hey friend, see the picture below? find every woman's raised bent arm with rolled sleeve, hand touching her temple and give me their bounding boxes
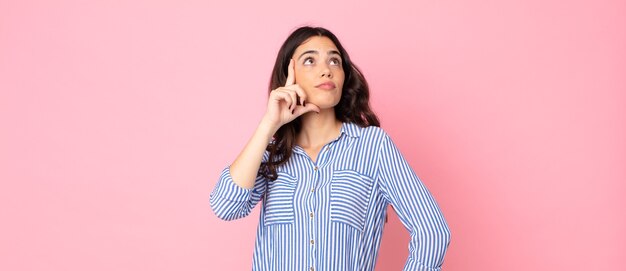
[210,60,319,220]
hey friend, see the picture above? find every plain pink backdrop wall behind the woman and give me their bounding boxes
[0,0,626,271]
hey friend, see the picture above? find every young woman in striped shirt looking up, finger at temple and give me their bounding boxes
[210,27,450,271]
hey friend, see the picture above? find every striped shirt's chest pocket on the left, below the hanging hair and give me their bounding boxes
[263,172,297,226]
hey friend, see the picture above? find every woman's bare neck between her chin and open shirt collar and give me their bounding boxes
[296,108,342,148]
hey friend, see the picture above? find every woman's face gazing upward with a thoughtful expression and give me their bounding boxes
[292,36,345,109]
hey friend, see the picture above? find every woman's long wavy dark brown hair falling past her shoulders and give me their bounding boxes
[259,26,380,180]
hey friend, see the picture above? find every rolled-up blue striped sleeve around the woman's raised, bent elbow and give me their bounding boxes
[209,166,266,220]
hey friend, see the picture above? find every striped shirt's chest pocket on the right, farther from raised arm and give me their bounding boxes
[330,170,373,231]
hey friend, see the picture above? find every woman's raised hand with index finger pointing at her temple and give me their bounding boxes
[263,59,320,131]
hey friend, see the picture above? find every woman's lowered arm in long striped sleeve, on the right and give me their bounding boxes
[378,134,450,271]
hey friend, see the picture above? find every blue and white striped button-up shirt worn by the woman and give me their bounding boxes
[210,123,450,271]
